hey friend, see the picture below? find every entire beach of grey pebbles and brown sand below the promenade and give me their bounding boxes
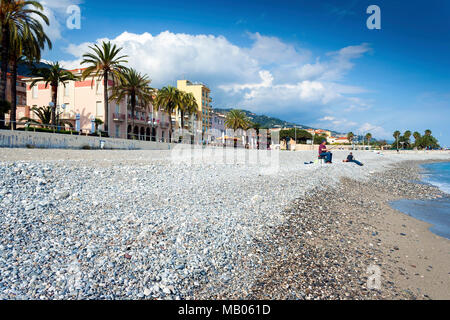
[0,149,450,299]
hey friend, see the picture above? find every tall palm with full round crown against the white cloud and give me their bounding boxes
[81,41,128,132]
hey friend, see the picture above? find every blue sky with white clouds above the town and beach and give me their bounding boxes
[42,0,450,146]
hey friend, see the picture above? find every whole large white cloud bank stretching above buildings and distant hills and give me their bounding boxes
[62,31,371,134]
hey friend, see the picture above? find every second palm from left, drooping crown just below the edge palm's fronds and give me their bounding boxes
[9,22,52,129]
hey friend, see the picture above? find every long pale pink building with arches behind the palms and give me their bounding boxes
[26,69,175,141]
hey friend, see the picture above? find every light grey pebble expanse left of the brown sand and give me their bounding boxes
[0,150,448,299]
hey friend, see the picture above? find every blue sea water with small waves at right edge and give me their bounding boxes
[391,162,450,239]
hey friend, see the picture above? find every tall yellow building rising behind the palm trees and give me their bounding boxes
[177,80,212,133]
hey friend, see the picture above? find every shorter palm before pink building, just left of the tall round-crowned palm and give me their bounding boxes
[30,62,78,125]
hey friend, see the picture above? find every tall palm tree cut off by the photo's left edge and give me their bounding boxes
[0,0,49,127]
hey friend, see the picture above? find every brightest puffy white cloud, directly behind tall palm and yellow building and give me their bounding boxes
[64,31,260,86]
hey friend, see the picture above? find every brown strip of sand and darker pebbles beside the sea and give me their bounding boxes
[243,161,450,299]
